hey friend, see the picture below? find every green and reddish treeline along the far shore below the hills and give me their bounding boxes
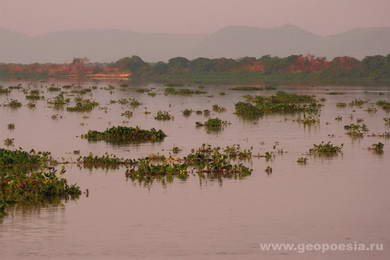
[0,54,390,85]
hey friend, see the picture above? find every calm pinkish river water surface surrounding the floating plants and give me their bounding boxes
[0,82,390,259]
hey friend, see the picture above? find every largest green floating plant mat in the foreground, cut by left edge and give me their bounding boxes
[0,148,81,217]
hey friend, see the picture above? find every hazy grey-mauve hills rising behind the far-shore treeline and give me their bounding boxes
[0,25,390,63]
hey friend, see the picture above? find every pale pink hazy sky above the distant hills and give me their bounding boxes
[0,0,390,35]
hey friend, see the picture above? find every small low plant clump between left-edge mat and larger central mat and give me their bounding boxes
[77,153,134,169]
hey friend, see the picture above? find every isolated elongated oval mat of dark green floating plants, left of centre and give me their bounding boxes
[81,126,166,144]
